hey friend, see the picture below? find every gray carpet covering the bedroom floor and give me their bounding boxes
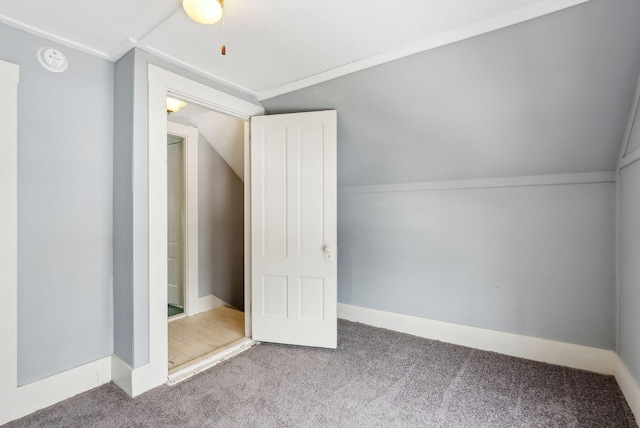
[3,321,637,428]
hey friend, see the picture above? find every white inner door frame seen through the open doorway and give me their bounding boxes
[167,121,199,319]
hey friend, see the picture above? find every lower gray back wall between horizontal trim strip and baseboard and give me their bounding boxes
[338,184,615,349]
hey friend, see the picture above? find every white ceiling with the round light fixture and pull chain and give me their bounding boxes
[0,0,588,99]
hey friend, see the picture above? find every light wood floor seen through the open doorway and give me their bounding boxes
[169,307,244,374]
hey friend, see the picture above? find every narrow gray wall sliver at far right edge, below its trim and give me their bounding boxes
[618,157,640,382]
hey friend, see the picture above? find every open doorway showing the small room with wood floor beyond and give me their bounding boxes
[166,102,245,380]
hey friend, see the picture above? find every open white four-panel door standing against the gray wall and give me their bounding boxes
[251,110,337,348]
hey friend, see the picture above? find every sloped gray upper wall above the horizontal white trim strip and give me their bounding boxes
[263,0,640,186]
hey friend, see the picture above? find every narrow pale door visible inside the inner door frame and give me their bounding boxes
[167,135,184,307]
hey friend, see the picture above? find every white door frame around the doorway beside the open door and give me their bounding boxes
[146,64,264,395]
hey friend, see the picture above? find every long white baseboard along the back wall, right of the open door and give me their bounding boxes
[338,303,616,375]
